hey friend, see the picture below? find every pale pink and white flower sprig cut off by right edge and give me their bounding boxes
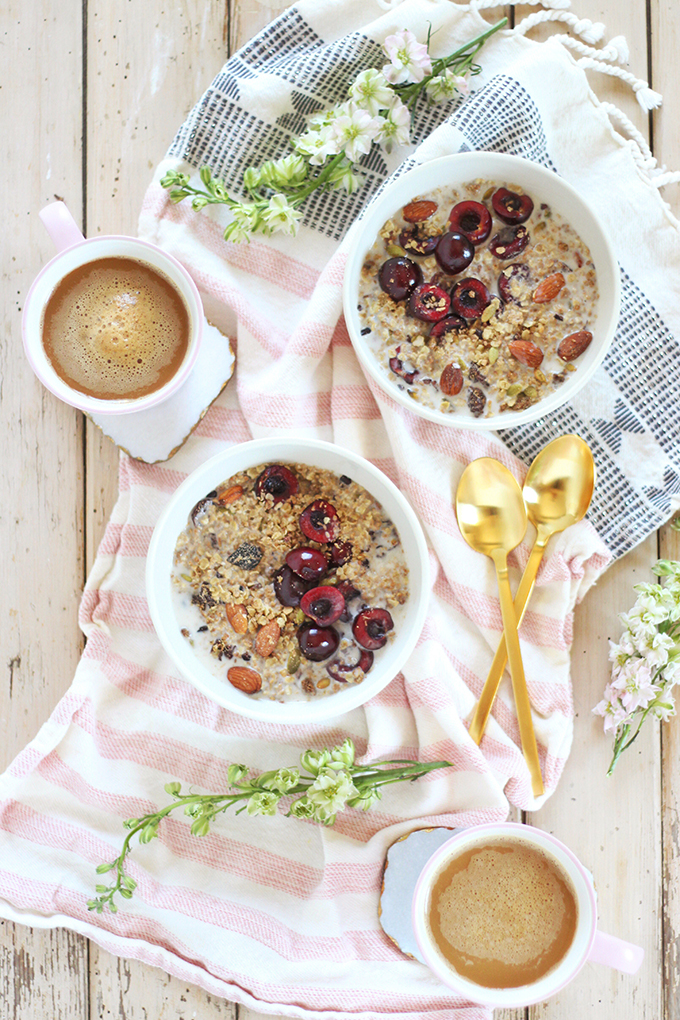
[592,560,680,775]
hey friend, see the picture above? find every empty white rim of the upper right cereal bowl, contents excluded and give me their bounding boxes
[343,149,621,431]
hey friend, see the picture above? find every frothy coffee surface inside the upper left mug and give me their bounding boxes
[43,258,190,400]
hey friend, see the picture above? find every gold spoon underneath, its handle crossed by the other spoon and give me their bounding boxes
[470,436,595,744]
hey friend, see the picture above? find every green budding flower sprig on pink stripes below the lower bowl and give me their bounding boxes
[88,738,451,914]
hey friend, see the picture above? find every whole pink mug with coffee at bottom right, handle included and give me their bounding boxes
[411,822,643,1009]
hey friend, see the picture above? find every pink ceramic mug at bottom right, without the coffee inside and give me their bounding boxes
[412,822,644,1009]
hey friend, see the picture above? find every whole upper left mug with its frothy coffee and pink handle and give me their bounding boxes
[21,202,204,415]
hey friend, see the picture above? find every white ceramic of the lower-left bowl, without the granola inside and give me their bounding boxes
[146,439,429,723]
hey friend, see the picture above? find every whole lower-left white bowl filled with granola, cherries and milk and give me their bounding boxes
[146,439,429,723]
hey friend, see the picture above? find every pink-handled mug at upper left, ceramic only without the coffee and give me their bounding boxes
[21,202,203,414]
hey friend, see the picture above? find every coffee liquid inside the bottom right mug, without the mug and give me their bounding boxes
[427,839,578,988]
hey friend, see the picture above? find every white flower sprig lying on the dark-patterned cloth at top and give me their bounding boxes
[160,17,508,242]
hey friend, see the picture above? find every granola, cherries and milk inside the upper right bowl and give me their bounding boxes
[358,180,598,417]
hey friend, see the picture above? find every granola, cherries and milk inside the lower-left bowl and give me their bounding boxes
[172,464,409,701]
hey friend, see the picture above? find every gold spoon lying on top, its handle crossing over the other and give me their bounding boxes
[456,457,543,797]
